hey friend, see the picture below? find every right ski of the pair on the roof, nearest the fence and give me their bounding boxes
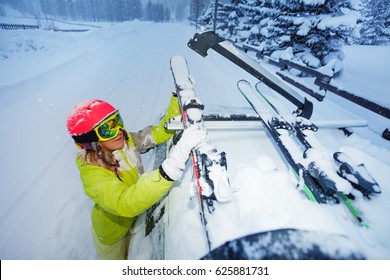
[255,82,381,197]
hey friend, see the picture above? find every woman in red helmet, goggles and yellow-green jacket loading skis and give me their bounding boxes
[67,96,206,259]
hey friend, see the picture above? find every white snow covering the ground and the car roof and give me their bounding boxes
[0,9,390,260]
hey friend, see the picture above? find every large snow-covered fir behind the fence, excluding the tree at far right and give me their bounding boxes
[202,0,359,72]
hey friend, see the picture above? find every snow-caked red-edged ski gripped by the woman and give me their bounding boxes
[170,55,232,251]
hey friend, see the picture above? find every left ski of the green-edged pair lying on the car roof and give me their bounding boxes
[237,80,368,227]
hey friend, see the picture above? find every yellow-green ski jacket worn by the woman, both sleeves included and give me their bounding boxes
[76,97,180,244]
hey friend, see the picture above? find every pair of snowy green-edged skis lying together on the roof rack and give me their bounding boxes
[237,80,381,227]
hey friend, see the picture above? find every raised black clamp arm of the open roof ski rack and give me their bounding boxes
[188,31,313,119]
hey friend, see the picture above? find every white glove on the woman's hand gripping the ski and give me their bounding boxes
[161,127,206,181]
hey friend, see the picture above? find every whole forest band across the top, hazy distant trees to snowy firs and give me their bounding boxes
[0,0,390,74]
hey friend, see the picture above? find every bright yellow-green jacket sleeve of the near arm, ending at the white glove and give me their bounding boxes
[77,159,173,217]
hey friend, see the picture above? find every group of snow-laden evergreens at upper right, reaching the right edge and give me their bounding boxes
[198,0,390,75]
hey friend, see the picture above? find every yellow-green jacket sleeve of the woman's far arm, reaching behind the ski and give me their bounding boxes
[130,96,180,152]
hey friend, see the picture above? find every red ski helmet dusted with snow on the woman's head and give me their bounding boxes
[66,99,118,144]
